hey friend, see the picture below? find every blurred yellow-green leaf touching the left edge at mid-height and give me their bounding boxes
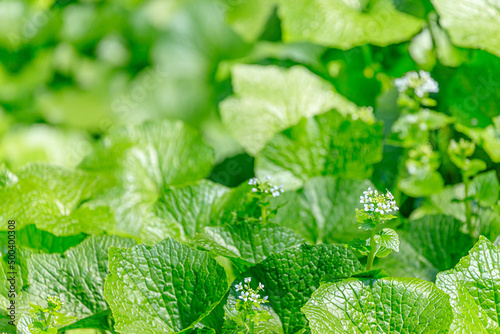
[0,164,114,236]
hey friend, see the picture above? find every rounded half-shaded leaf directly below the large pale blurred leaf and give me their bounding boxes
[255,111,382,188]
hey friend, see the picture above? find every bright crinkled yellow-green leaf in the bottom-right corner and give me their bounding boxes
[436,237,500,333]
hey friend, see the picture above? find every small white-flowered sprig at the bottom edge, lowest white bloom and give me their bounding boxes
[232,277,273,334]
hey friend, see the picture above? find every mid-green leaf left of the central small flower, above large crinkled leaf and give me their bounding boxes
[153,180,229,237]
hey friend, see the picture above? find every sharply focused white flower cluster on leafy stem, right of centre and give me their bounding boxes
[349,187,399,270]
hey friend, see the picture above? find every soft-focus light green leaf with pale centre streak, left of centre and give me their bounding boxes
[82,121,214,243]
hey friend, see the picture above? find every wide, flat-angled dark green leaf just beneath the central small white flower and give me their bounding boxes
[193,222,304,269]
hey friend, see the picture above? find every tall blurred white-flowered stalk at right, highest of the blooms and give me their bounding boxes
[389,71,452,197]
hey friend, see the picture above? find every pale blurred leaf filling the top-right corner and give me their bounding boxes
[432,0,500,56]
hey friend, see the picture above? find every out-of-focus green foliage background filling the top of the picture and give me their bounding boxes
[0,0,500,177]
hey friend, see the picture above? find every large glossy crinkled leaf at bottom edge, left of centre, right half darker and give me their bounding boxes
[104,238,228,334]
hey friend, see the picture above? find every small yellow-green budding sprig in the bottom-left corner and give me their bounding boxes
[29,296,77,334]
